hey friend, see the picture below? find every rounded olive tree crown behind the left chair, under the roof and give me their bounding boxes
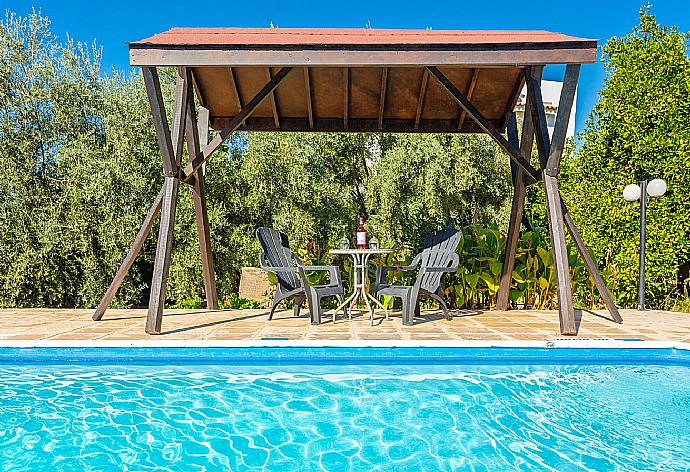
[236,133,371,258]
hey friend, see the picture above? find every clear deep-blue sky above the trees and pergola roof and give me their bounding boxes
[4,0,690,131]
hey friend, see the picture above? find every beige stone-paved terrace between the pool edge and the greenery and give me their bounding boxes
[0,308,690,343]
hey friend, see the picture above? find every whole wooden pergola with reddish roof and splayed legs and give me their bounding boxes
[88,28,622,334]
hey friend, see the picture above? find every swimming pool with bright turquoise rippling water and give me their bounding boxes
[0,346,690,471]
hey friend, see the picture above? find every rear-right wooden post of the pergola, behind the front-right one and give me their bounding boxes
[496,66,543,310]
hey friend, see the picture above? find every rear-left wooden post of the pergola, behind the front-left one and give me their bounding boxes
[186,97,218,310]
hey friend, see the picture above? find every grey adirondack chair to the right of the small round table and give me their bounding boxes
[374,229,462,326]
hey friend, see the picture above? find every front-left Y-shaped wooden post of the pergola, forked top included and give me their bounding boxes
[142,67,181,334]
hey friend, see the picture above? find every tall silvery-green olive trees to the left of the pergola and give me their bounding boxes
[0,13,160,306]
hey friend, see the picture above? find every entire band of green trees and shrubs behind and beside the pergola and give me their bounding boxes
[5,10,690,308]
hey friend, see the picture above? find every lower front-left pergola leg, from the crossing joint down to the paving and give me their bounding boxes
[146,177,180,334]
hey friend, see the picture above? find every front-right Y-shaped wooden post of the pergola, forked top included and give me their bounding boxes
[527,64,580,334]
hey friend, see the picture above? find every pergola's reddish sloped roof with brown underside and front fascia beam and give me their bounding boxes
[129,28,597,132]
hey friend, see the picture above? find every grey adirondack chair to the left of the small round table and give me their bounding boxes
[256,227,345,324]
